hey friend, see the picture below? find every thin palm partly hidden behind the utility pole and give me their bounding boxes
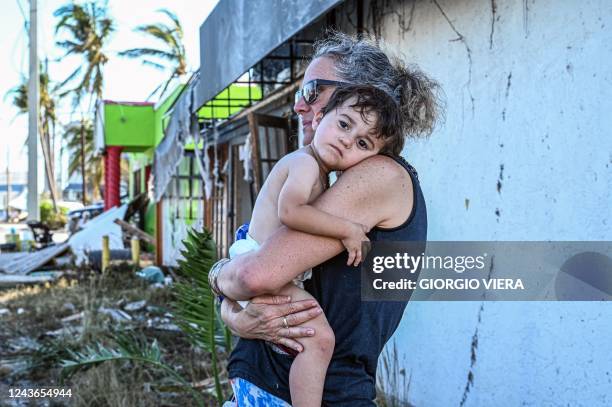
[9,64,58,212]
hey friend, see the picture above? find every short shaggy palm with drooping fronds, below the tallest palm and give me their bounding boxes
[64,119,103,204]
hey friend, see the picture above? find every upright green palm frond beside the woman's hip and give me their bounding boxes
[173,229,231,404]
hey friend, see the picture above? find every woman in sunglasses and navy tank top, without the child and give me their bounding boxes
[213,34,438,406]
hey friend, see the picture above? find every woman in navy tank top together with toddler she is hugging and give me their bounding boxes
[211,34,438,407]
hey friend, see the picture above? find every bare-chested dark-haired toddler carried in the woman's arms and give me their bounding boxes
[230,85,403,407]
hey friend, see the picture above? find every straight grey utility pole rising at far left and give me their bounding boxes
[28,0,40,220]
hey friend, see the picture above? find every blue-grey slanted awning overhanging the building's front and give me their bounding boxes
[196,0,342,108]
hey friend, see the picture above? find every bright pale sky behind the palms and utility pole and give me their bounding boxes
[0,0,218,185]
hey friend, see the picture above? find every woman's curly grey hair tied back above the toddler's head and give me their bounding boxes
[313,31,442,137]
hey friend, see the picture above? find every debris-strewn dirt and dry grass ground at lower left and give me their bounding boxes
[0,265,227,406]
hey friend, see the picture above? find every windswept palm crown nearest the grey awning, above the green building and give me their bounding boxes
[119,9,187,99]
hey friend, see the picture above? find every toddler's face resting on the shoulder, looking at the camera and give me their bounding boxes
[312,98,384,171]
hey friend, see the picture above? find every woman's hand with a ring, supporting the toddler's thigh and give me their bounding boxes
[221,295,323,352]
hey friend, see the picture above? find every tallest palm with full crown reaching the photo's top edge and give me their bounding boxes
[53,1,114,203]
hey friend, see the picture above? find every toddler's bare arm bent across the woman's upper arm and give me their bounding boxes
[278,154,369,265]
